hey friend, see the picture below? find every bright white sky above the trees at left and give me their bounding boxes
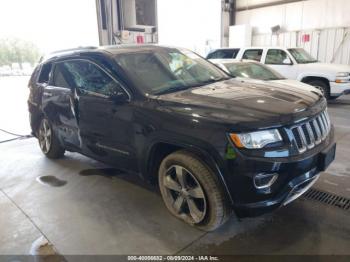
[0,0,98,53]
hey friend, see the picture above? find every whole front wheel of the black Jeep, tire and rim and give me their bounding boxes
[158,150,231,231]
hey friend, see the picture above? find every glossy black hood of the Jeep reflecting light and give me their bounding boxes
[157,79,326,129]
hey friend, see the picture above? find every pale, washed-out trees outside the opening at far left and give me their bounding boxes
[0,38,40,66]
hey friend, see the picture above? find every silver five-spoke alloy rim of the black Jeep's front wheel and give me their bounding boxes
[163,165,207,224]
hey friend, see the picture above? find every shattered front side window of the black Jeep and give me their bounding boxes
[63,60,123,96]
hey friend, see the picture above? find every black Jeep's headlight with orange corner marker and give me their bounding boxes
[230,129,282,149]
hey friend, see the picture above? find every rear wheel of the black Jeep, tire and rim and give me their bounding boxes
[38,117,65,159]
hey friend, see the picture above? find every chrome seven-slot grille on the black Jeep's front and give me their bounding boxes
[291,110,331,153]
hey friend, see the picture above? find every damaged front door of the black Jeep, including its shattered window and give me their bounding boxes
[59,59,137,171]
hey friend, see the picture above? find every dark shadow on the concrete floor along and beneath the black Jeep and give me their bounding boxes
[41,153,334,255]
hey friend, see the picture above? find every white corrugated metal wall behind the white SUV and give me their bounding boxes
[252,28,350,65]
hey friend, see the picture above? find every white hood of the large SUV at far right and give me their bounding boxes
[298,62,350,77]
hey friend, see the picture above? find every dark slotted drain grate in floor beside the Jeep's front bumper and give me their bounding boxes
[304,188,350,210]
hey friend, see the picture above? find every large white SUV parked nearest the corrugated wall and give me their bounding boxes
[207,47,350,99]
